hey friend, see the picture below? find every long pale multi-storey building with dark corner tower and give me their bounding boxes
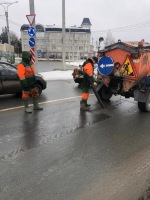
[21,18,93,60]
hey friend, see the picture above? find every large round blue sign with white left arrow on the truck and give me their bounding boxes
[98,56,114,75]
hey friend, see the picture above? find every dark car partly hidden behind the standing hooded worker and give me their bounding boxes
[0,61,47,95]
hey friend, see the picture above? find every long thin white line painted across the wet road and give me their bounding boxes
[0,94,94,112]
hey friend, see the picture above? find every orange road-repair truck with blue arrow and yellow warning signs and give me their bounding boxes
[97,42,150,112]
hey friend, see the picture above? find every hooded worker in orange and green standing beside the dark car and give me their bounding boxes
[17,51,43,113]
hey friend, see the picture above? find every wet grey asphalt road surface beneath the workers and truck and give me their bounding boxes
[0,61,150,200]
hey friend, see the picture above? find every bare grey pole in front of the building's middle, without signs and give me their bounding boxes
[62,0,66,70]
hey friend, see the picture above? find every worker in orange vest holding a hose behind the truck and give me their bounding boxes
[80,57,98,111]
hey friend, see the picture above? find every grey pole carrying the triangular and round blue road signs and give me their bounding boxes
[29,0,38,73]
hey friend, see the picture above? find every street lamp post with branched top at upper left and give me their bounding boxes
[0,1,18,45]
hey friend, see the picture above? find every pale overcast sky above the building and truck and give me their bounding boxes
[0,0,150,42]
